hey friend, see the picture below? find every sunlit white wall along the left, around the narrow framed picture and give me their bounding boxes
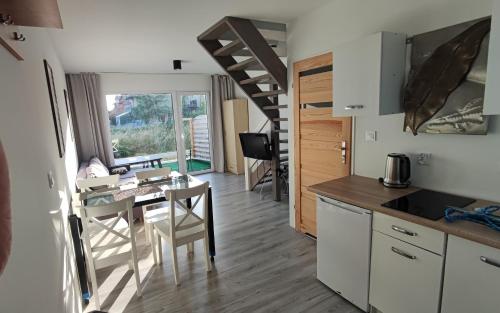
[0,29,81,313]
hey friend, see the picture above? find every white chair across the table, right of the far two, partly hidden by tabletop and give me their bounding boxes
[135,167,172,251]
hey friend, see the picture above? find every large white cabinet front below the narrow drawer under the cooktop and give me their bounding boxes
[370,231,443,313]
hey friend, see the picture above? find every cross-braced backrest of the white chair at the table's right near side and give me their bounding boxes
[165,182,208,238]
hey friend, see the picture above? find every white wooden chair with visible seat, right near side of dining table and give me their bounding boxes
[153,182,212,285]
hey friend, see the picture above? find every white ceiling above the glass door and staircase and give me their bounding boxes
[50,0,331,73]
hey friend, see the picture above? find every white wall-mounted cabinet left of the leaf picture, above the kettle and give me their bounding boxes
[333,32,406,116]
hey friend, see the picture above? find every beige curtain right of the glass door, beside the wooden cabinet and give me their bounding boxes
[210,75,234,172]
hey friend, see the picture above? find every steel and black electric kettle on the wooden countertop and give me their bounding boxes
[383,153,410,188]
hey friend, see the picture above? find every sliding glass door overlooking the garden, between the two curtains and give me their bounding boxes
[106,92,212,174]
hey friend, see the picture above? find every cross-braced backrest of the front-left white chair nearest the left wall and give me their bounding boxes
[80,197,135,264]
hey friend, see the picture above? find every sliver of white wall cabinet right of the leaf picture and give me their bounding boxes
[483,0,500,115]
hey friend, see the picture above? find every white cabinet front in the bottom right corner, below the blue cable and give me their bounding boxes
[441,235,500,313]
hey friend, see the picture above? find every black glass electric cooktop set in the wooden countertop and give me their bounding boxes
[382,189,476,221]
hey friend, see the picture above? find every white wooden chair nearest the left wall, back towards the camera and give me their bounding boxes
[80,197,142,310]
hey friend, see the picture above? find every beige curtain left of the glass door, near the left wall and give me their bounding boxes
[66,73,114,166]
